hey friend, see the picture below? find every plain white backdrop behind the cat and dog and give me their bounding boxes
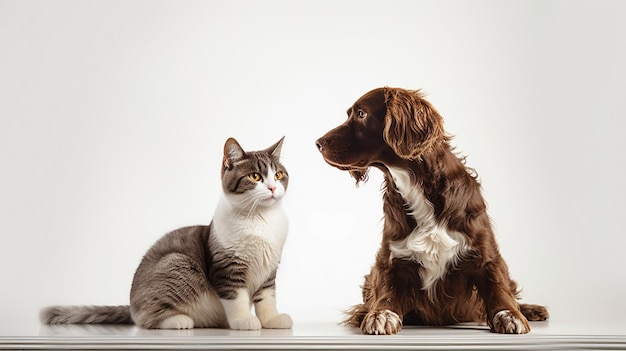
[0,0,626,334]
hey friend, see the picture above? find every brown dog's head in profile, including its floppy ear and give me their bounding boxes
[316,88,445,183]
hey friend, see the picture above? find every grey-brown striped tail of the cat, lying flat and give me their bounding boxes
[40,305,133,324]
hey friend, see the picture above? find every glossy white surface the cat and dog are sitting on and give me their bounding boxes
[0,321,626,350]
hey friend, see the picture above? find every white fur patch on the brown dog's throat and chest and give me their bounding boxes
[389,167,467,292]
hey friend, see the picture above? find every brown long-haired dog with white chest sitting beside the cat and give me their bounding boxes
[316,87,549,335]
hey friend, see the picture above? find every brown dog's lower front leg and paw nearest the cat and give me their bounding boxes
[360,267,404,335]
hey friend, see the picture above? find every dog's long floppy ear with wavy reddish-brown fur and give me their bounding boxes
[383,88,445,160]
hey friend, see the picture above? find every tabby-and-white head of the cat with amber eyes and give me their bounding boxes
[222,137,289,210]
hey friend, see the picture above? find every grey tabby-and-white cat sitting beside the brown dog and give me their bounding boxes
[41,137,293,330]
